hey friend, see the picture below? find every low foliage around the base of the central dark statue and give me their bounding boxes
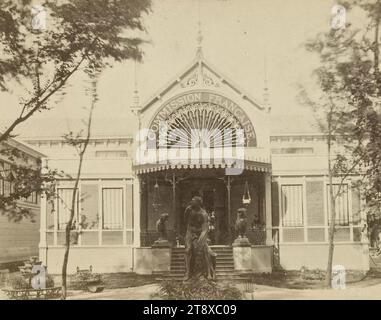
[151,279,242,300]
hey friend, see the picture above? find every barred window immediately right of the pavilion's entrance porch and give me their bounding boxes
[281,185,303,227]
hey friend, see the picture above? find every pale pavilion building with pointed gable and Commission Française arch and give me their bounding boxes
[27,50,369,274]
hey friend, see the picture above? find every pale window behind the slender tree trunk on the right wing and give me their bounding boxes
[327,184,349,226]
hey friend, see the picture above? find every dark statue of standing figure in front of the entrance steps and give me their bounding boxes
[185,196,216,280]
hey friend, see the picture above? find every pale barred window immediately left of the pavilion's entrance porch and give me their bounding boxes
[102,188,123,230]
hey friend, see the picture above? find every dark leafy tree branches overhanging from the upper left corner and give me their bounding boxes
[0,0,151,219]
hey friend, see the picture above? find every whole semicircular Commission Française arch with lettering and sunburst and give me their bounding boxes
[149,91,256,148]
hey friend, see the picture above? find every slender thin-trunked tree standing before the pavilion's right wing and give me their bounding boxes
[301,58,359,287]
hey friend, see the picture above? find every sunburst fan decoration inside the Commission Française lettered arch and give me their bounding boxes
[159,102,246,148]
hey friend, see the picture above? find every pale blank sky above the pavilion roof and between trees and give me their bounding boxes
[0,0,335,137]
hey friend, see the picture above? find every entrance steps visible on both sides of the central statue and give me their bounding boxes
[160,246,250,281]
